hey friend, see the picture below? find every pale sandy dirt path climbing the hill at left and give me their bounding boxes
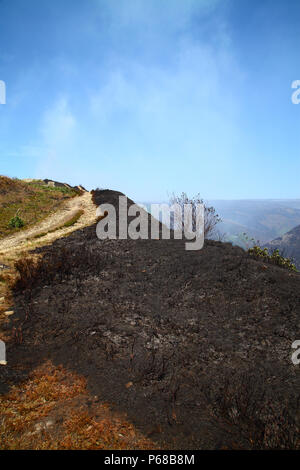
[0,192,96,263]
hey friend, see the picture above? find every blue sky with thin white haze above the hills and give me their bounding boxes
[0,0,300,201]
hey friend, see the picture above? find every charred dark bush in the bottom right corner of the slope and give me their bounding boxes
[207,372,300,450]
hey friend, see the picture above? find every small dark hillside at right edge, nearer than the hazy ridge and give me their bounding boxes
[265,225,300,270]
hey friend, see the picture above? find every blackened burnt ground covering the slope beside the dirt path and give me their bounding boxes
[0,191,300,449]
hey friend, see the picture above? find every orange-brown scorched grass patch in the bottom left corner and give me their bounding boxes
[0,362,155,450]
